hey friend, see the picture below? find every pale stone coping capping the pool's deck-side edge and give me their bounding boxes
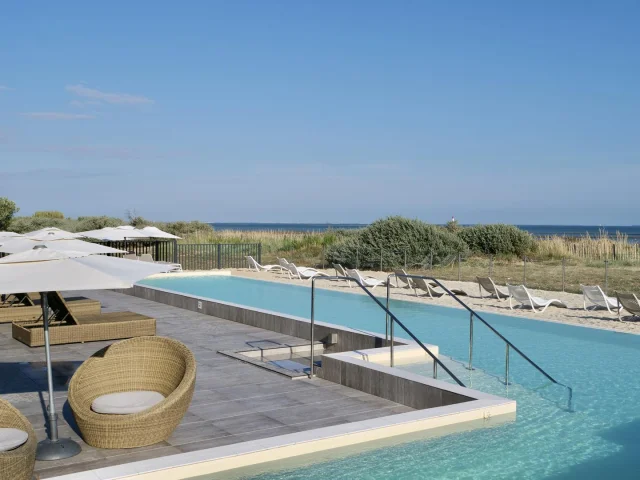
[52,285,516,480]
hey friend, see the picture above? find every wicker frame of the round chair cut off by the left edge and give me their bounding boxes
[0,399,38,480]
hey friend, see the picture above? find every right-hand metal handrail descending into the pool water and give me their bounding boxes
[390,273,573,410]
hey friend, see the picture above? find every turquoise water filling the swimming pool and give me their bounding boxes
[143,277,640,480]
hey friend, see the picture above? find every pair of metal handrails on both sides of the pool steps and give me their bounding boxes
[309,273,573,411]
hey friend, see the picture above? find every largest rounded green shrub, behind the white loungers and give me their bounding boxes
[326,217,467,270]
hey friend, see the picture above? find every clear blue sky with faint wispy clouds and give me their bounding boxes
[0,0,640,225]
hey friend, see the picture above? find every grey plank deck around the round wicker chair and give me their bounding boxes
[0,292,411,478]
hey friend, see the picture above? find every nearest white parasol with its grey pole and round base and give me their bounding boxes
[0,245,171,460]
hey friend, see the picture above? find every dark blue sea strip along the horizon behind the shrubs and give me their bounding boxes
[211,223,640,241]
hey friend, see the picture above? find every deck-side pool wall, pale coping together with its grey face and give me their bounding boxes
[61,286,516,480]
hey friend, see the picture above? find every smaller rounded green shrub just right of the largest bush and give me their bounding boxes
[457,224,534,256]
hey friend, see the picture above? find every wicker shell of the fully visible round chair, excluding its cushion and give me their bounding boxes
[69,337,196,448]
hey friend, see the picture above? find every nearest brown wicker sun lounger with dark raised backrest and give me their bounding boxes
[12,292,156,347]
